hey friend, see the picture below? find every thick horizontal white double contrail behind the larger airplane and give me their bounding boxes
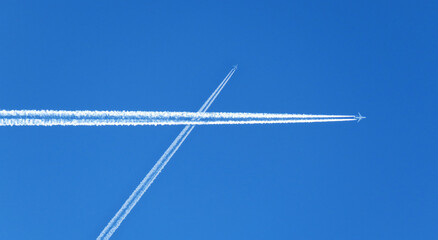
[0,110,356,126]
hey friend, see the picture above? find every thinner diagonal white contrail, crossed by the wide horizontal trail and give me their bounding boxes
[97,66,237,239]
